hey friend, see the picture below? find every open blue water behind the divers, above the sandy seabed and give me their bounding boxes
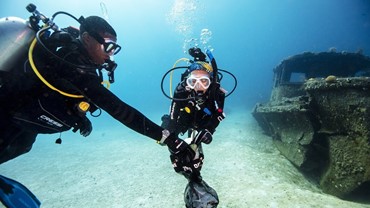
[0,0,370,206]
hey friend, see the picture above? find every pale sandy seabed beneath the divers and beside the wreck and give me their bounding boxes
[0,110,370,208]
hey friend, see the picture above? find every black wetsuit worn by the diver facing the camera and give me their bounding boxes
[162,81,225,182]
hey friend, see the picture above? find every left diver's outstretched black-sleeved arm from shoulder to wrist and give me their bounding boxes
[50,41,184,144]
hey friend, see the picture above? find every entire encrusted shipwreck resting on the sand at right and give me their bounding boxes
[252,51,370,198]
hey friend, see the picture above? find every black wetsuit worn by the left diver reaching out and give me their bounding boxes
[0,33,163,164]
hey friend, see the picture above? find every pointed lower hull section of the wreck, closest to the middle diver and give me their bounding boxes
[253,102,315,169]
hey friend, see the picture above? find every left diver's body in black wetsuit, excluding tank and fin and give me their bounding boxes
[0,16,193,164]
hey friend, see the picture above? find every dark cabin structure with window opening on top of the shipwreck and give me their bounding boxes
[270,52,370,101]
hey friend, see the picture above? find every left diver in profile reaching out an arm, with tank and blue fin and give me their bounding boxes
[0,4,195,207]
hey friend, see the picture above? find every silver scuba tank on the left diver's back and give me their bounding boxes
[0,17,36,72]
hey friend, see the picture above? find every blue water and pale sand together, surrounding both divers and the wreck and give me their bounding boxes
[0,0,370,207]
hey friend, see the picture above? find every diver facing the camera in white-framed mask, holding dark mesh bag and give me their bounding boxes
[162,47,236,208]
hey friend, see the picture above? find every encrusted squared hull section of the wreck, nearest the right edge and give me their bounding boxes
[306,78,370,196]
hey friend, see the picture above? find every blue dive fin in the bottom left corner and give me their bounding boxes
[0,175,41,208]
